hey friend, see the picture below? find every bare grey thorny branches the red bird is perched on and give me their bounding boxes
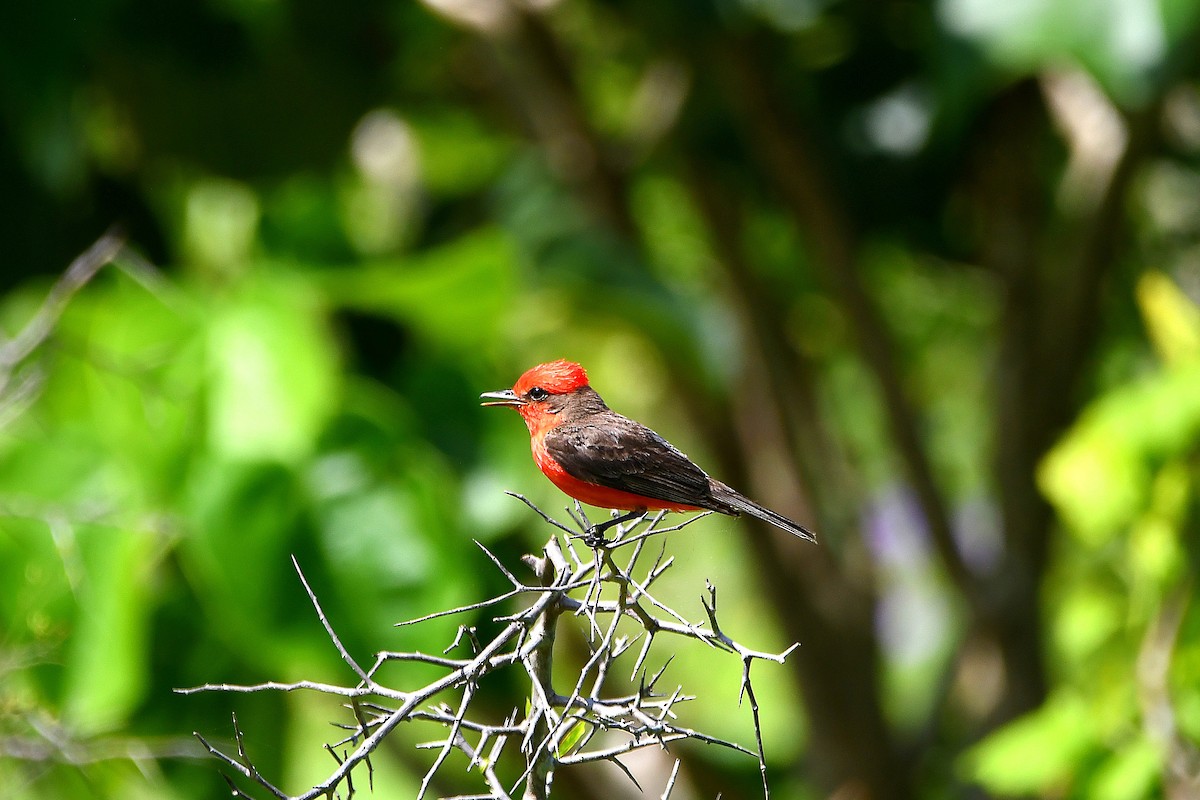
[178,494,798,800]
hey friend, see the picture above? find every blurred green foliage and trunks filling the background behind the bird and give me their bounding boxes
[0,0,1200,800]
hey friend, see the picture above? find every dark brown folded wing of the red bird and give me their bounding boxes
[544,411,722,510]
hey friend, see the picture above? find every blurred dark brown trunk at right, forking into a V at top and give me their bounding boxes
[972,80,1158,728]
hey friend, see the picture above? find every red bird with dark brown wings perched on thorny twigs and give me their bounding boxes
[480,361,816,542]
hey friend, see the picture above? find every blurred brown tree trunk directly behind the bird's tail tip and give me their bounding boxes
[689,158,912,800]
